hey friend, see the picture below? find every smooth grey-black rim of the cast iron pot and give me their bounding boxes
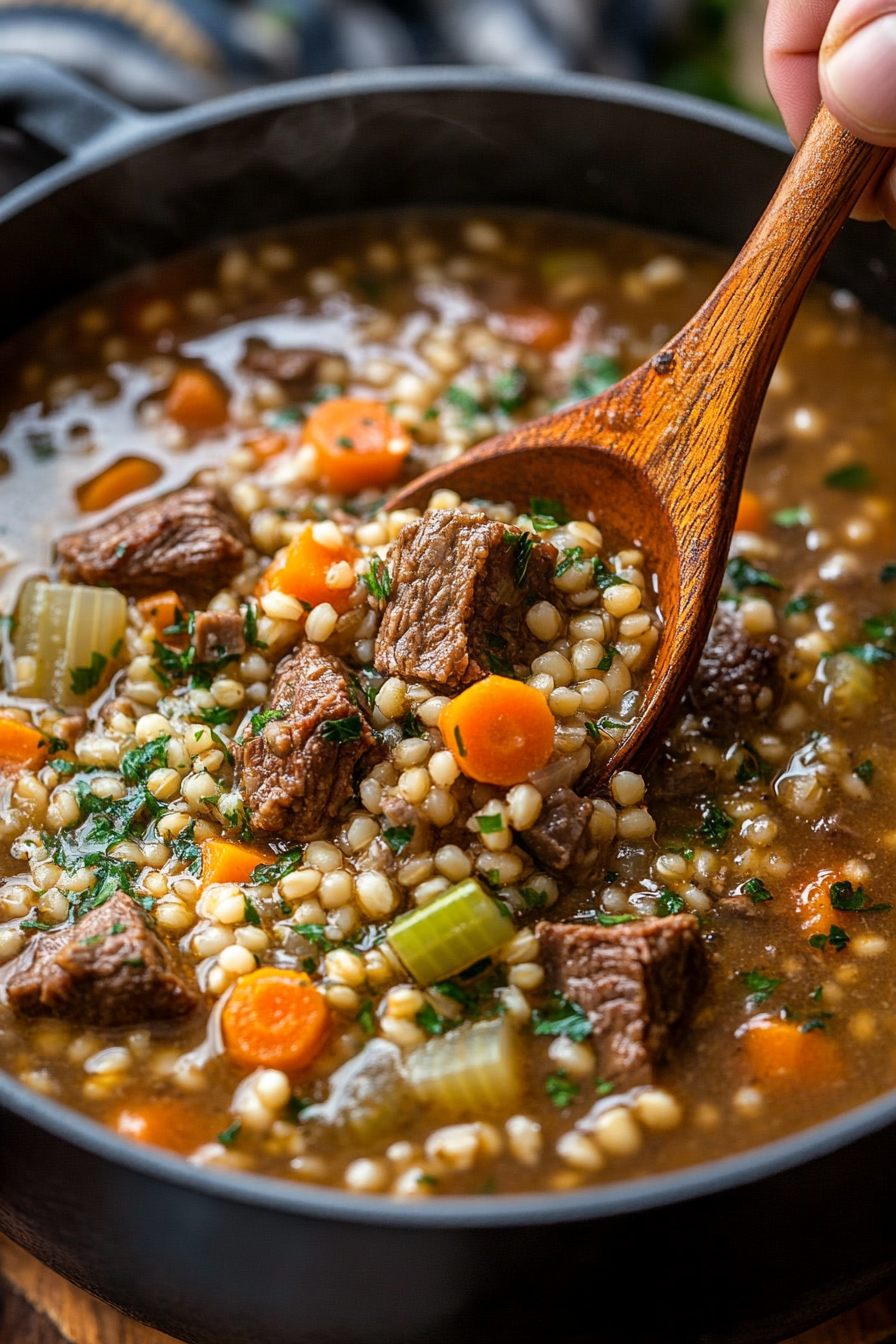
[0,66,881,1230]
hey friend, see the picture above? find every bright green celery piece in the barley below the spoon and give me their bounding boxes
[388,878,513,985]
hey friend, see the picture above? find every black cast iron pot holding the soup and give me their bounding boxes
[0,60,896,1344]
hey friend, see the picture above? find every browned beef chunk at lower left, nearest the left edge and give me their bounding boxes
[7,891,199,1027]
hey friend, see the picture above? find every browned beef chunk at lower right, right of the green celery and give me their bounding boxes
[536,914,707,1086]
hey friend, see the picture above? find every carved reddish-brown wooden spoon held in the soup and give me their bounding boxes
[390,106,892,792]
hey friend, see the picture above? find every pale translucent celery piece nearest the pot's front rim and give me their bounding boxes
[406,1017,521,1114]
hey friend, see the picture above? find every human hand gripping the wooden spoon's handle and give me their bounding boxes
[766,0,896,228]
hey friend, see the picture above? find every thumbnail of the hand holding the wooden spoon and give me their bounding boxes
[823,13,896,136]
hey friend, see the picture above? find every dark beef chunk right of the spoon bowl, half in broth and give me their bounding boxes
[688,606,783,724]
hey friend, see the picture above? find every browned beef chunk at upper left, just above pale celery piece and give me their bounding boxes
[56,485,246,601]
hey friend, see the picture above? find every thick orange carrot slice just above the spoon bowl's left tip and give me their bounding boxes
[302,396,411,495]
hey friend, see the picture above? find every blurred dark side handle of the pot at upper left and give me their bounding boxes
[0,56,146,157]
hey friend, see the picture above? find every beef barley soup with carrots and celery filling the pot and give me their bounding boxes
[0,215,896,1199]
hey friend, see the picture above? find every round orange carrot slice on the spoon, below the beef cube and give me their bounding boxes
[439,676,555,785]
